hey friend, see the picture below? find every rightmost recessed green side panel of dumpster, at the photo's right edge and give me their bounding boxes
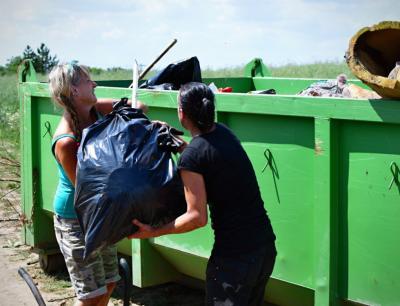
[339,122,400,305]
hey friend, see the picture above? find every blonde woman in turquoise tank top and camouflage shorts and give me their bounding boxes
[49,62,145,305]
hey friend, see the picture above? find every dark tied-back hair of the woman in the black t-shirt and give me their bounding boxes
[179,82,215,133]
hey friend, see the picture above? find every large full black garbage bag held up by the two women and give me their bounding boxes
[75,100,186,258]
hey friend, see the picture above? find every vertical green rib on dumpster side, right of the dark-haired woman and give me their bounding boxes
[314,117,338,306]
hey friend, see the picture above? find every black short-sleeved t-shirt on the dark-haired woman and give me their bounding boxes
[178,123,275,255]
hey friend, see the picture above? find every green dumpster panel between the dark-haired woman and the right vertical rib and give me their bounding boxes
[218,112,314,288]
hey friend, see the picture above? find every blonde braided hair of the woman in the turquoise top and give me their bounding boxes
[49,62,89,141]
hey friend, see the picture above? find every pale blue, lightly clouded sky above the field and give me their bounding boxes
[0,0,400,68]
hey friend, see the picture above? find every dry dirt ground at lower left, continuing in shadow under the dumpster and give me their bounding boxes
[0,150,204,306]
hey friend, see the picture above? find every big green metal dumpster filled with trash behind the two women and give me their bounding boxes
[19,61,400,306]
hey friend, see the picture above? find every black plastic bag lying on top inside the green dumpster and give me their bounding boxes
[140,56,201,90]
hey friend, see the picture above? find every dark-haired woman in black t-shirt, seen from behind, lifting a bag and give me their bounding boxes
[130,83,276,306]
